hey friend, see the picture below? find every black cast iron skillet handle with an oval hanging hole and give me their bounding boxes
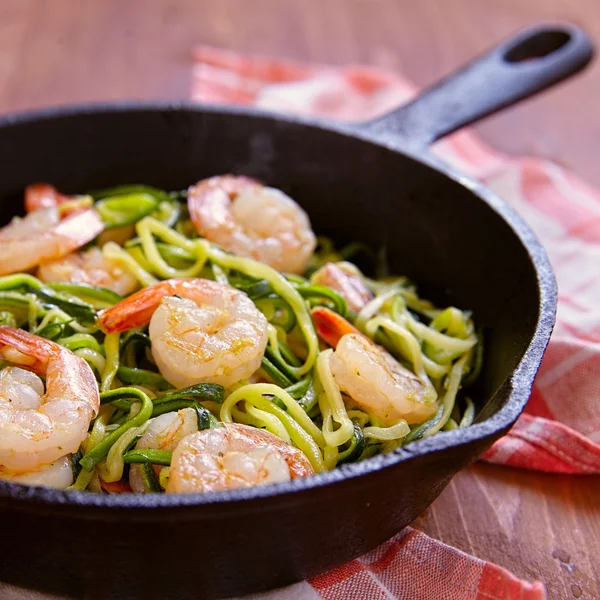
[359,23,594,148]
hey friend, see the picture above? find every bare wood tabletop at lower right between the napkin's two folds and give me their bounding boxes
[415,463,600,599]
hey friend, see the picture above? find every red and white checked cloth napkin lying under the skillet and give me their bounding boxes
[192,46,600,600]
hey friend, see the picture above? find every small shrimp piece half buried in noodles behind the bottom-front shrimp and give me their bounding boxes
[129,408,198,493]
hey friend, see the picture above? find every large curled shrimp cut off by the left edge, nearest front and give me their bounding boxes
[0,326,100,473]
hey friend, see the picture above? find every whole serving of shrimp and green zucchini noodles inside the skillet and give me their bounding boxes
[0,175,482,493]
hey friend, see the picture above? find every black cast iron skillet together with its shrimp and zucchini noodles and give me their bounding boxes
[0,24,592,599]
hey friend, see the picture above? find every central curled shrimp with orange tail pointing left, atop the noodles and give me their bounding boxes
[98,279,268,388]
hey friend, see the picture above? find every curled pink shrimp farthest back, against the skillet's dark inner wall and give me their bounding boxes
[188,175,316,273]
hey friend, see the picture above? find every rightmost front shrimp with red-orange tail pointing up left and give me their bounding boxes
[312,307,439,425]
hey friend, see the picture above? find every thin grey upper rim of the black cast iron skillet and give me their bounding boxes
[0,100,557,508]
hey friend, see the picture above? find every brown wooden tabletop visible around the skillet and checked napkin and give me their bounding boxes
[0,0,600,599]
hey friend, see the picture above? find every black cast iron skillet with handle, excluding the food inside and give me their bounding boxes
[0,24,592,600]
